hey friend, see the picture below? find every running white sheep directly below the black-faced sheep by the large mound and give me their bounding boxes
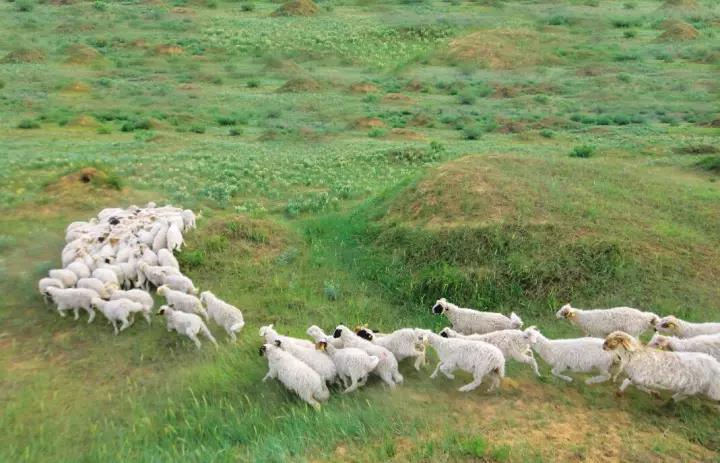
[427,331,505,392]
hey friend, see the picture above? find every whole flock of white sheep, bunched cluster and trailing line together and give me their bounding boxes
[38,203,720,407]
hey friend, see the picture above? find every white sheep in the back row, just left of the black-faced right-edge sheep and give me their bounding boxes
[555,304,659,338]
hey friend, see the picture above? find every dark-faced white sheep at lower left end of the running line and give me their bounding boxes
[260,344,330,410]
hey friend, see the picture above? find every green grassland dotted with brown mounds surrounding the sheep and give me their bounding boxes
[0,0,720,462]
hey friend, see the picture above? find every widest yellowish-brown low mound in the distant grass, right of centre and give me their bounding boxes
[447,29,540,69]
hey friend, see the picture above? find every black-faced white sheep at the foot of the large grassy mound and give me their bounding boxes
[432,298,523,334]
